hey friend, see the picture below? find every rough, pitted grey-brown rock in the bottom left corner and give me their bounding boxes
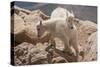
[14,42,34,65]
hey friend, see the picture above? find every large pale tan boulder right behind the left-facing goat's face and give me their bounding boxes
[24,10,50,38]
